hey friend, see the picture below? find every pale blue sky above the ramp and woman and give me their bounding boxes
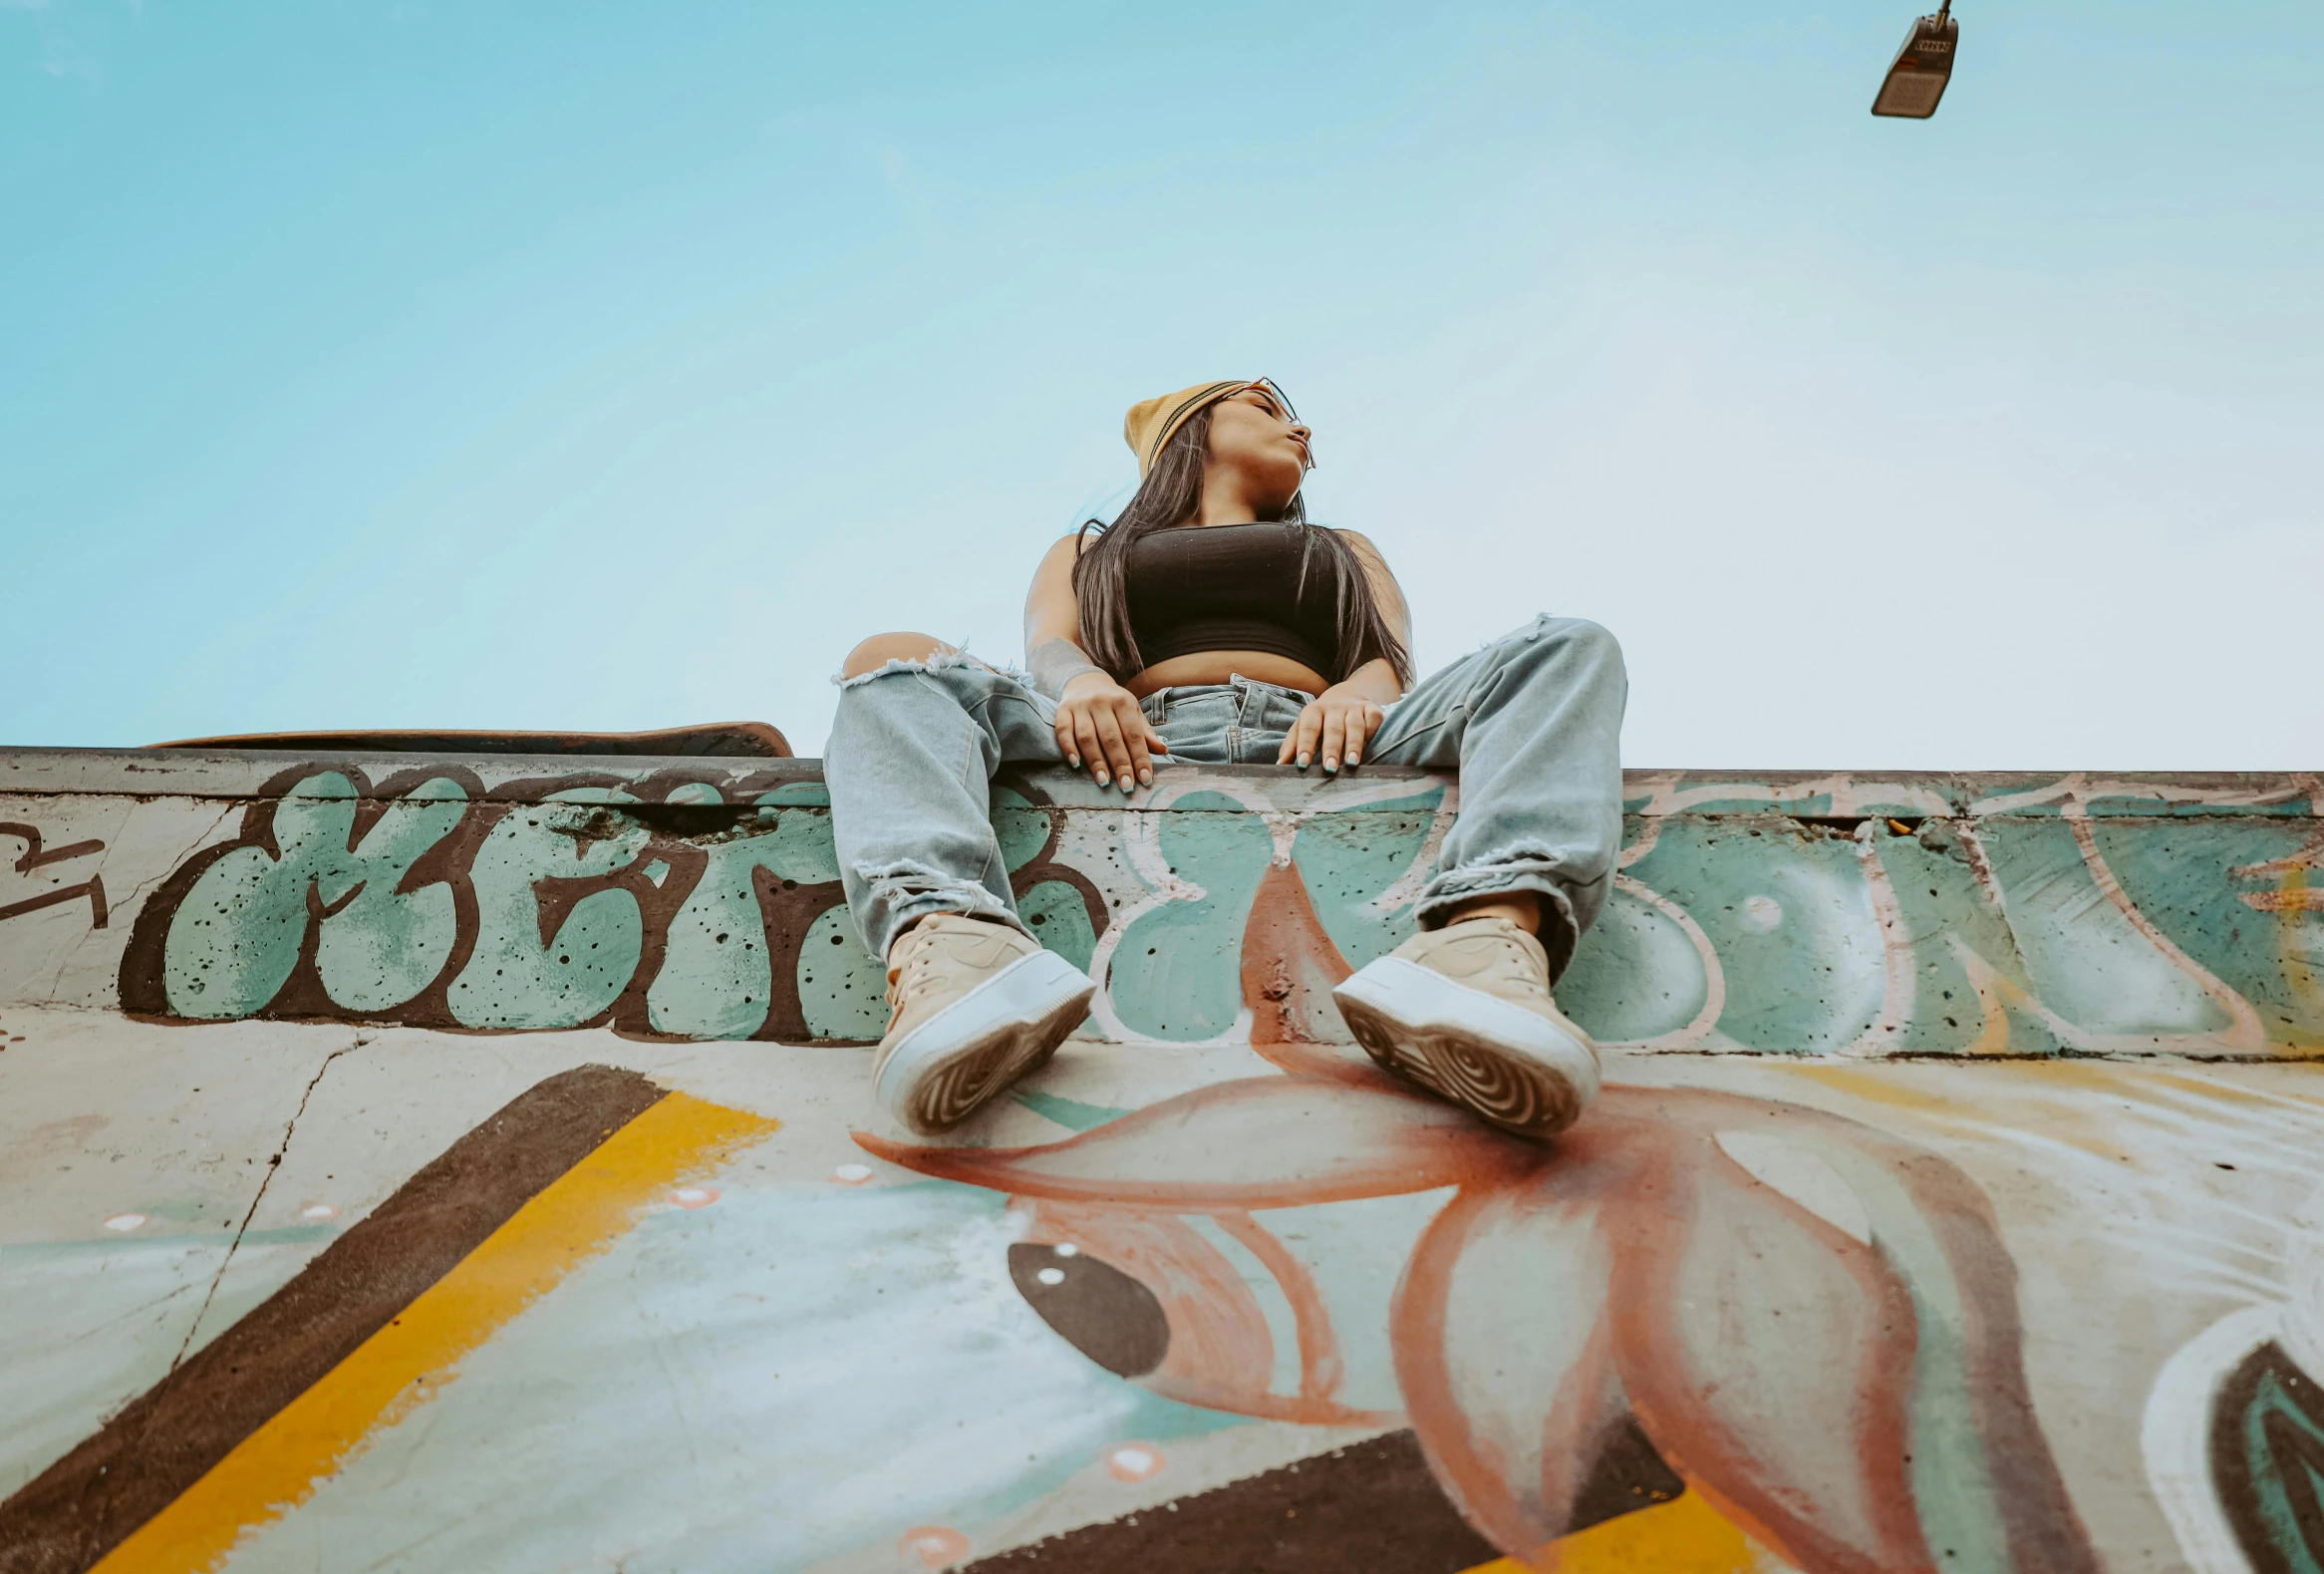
[0,0,2324,770]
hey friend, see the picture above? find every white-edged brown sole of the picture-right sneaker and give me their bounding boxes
[1331,956,1598,1139]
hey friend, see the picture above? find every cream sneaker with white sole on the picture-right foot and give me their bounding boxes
[1331,918,1598,1137]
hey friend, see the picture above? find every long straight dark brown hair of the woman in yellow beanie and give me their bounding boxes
[1073,407,1413,688]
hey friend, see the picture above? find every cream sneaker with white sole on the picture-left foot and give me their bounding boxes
[872,914,1097,1137]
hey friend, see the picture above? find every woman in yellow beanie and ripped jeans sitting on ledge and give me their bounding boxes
[825,379,1626,1137]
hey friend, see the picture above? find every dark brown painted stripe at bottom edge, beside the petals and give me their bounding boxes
[960,1432,1501,1574]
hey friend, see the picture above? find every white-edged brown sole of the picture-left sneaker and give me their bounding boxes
[872,951,1097,1137]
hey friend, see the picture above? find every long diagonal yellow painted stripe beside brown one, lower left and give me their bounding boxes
[98,1093,778,1574]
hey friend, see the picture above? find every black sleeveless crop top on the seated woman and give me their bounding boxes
[1122,525,1345,681]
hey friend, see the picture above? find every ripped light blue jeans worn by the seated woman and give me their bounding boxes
[823,616,1629,977]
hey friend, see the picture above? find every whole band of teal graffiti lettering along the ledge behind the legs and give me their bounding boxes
[95,765,2324,1056]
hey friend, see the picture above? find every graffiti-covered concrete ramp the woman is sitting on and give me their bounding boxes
[0,749,2324,1574]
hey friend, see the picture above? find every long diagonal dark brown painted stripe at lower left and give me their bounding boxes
[0,1065,665,1574]
